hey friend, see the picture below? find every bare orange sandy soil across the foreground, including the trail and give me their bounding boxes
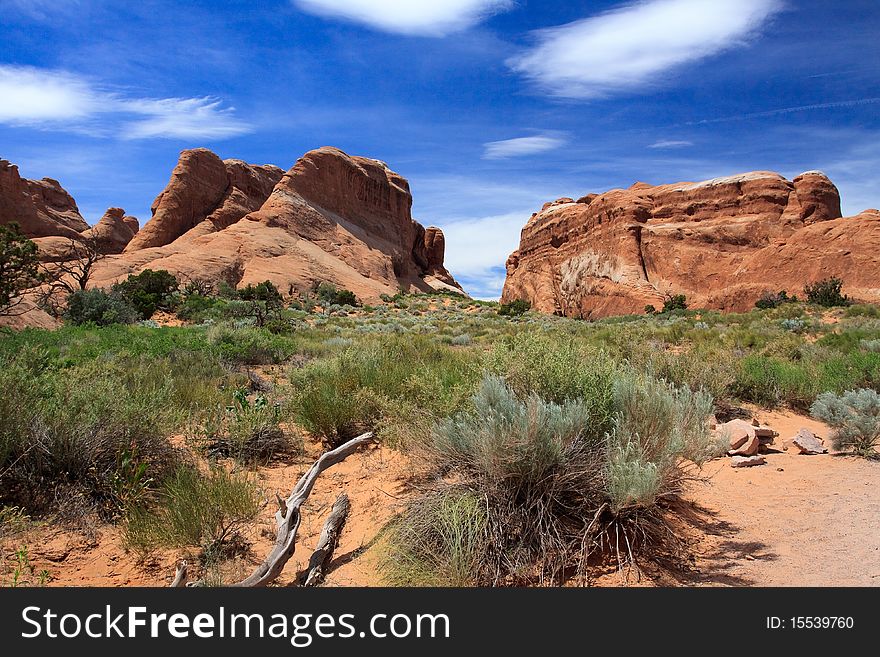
[0,411,880,586]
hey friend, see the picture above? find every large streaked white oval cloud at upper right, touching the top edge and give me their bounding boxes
[508,0,783,98]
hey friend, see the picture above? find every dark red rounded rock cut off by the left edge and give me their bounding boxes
[0,160,89,238]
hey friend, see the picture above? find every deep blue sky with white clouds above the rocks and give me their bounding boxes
[0,0,880,298]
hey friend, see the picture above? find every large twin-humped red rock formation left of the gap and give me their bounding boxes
[92,147,460,301]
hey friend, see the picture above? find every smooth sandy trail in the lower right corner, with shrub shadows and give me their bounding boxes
[676,412,880,586]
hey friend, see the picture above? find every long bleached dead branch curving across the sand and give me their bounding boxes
[172,432,373,587]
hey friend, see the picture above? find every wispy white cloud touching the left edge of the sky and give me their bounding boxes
[0,65,252,139]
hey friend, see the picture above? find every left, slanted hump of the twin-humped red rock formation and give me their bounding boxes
[126,148,282,251]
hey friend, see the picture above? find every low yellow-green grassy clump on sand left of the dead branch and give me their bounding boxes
[124,465,261,558]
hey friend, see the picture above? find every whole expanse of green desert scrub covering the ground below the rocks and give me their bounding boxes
[0,270,880,585]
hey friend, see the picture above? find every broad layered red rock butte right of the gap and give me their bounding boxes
[502,171,880,318]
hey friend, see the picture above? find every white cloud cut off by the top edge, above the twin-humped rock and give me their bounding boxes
[293,0,513,36]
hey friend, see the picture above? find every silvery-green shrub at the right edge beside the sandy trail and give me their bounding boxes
[810,389,880,459]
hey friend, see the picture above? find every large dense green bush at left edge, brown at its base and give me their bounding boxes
[0,361,178,518]
